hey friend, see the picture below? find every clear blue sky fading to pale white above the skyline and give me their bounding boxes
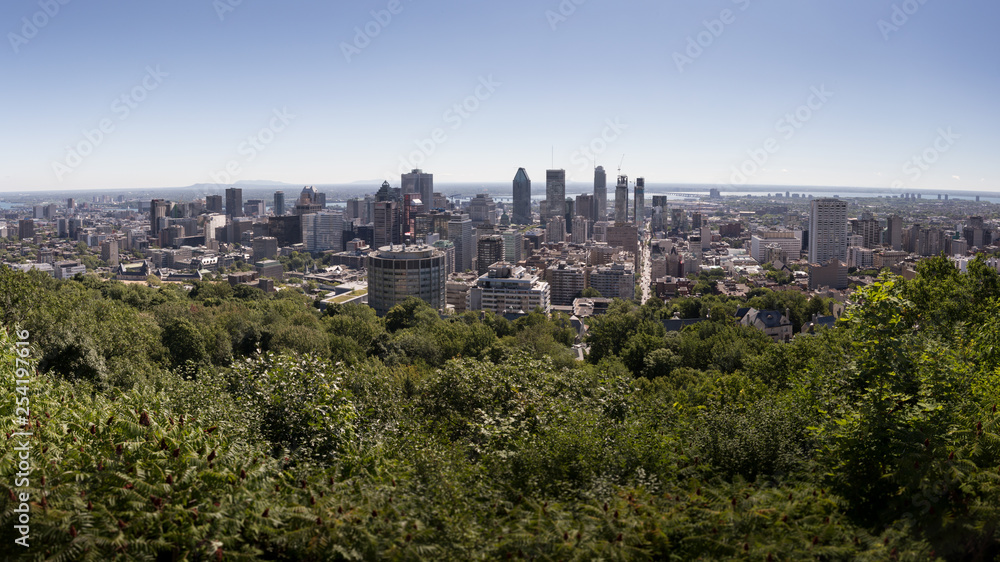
[0,0,1000,191]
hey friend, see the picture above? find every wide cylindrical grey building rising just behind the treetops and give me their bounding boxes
[368,244,446,316]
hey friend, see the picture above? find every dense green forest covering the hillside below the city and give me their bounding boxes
[0,257,1000,561]
